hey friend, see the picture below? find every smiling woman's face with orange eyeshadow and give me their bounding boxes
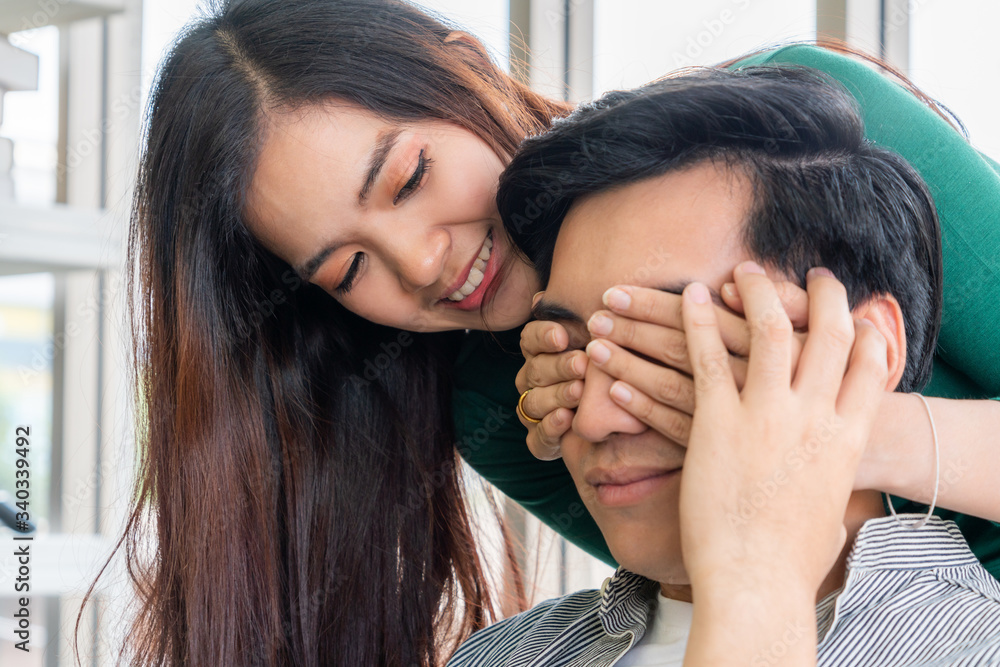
[246,103,539,331]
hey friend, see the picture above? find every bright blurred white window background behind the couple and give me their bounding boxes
[0,0,1000,667]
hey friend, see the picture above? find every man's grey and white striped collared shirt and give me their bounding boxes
[448,515,1000,667]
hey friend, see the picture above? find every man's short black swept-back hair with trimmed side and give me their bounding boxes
[497,67,942,391]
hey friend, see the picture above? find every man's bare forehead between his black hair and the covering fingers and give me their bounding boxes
[535,163,749,331]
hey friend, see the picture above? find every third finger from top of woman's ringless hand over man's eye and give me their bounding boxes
[587,340,696,414]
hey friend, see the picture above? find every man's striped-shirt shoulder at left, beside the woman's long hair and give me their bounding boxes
[448,589,601,667]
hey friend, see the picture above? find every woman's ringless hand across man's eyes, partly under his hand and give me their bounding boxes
[587,282,808,445]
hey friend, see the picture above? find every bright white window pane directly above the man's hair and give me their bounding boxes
[594,0,816,96]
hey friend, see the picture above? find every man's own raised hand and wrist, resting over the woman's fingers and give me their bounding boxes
[680,264,888,664]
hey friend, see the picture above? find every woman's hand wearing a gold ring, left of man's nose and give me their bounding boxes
[514,302,587,461]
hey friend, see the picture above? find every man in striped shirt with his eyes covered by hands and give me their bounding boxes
[450,68,1000,666]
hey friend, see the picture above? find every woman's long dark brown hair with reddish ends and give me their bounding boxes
[78,0,568,667]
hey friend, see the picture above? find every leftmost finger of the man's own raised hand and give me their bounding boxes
[682,283,739,409]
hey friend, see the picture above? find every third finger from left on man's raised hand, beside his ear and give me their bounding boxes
[792,268,855,401]
